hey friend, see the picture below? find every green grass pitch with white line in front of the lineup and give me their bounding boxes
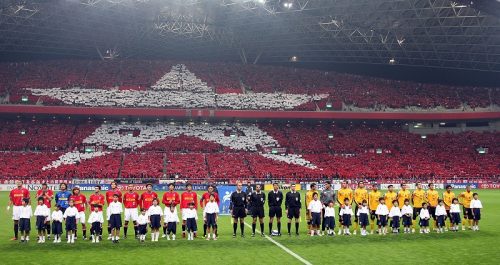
[0,190,500,264]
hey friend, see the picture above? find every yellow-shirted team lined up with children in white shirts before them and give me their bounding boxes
[306,181,482,236]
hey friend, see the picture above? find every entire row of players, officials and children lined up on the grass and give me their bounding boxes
[8,179,482,243]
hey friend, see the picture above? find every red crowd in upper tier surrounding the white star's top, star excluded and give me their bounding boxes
[0,60,500,111]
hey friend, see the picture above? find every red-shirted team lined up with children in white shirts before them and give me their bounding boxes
[7,181,220,243]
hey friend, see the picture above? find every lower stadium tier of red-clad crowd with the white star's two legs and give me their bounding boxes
[0,121,500,180]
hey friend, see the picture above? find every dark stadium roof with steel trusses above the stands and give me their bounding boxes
[0,0,500,72]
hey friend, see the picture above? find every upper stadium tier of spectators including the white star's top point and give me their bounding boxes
[0,60,500,112]
